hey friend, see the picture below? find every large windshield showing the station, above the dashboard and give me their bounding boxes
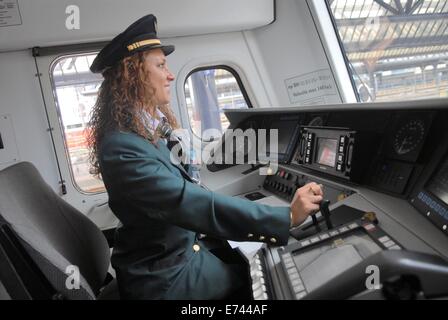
[326,0,448,102]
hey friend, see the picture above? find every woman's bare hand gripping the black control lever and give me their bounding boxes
[291,182,324,227]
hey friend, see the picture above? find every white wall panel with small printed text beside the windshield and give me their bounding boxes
[245,0,341,107]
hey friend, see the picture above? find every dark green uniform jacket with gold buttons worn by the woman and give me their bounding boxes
[99,131,290,299]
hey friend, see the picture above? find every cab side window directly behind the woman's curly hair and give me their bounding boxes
[51,54,105,193]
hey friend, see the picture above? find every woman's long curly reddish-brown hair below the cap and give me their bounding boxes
[87,52,179,176]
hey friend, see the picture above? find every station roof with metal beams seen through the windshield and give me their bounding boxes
[327,0,448,70]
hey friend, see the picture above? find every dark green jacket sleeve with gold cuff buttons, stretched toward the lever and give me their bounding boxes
[100,133,290,245]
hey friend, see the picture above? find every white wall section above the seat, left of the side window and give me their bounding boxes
[0,51,59,184]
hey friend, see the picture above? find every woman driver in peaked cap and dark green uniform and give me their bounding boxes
[89,15,323,299]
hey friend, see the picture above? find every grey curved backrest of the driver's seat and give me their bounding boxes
[0,162,110,299]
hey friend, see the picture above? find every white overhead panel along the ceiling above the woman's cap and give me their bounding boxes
[0,0,274,51]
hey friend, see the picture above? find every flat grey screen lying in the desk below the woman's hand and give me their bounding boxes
[292,229,382,292]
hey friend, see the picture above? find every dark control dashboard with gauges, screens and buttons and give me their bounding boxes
[216,99,448,299]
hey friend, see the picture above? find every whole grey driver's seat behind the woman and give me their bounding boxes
[0,162,118,300]
